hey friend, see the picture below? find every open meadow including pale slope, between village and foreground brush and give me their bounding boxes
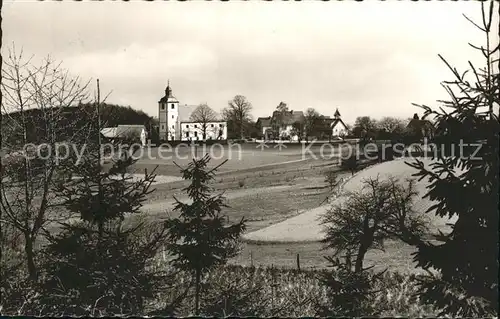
[125,143,454,273]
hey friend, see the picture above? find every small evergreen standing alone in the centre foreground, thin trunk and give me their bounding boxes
[166,154,245,315]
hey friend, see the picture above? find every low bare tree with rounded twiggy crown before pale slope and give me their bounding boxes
[323,177,427,272]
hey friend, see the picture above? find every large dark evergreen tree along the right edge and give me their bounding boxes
[409,2,500,316]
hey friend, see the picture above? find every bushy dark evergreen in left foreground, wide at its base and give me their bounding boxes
[32,105,171,315]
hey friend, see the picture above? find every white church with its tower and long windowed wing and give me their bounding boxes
[158,84,227,141]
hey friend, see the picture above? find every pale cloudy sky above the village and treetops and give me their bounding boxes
[2,0,496,123]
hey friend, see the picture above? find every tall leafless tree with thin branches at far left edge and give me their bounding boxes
[0,46,92,279]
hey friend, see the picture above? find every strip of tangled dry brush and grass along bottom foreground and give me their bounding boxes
[164,265,436,317]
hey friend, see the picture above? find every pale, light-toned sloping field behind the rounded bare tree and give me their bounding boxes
[244,160,460,242]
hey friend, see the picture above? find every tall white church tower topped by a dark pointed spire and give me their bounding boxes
[158,81,180,141]
